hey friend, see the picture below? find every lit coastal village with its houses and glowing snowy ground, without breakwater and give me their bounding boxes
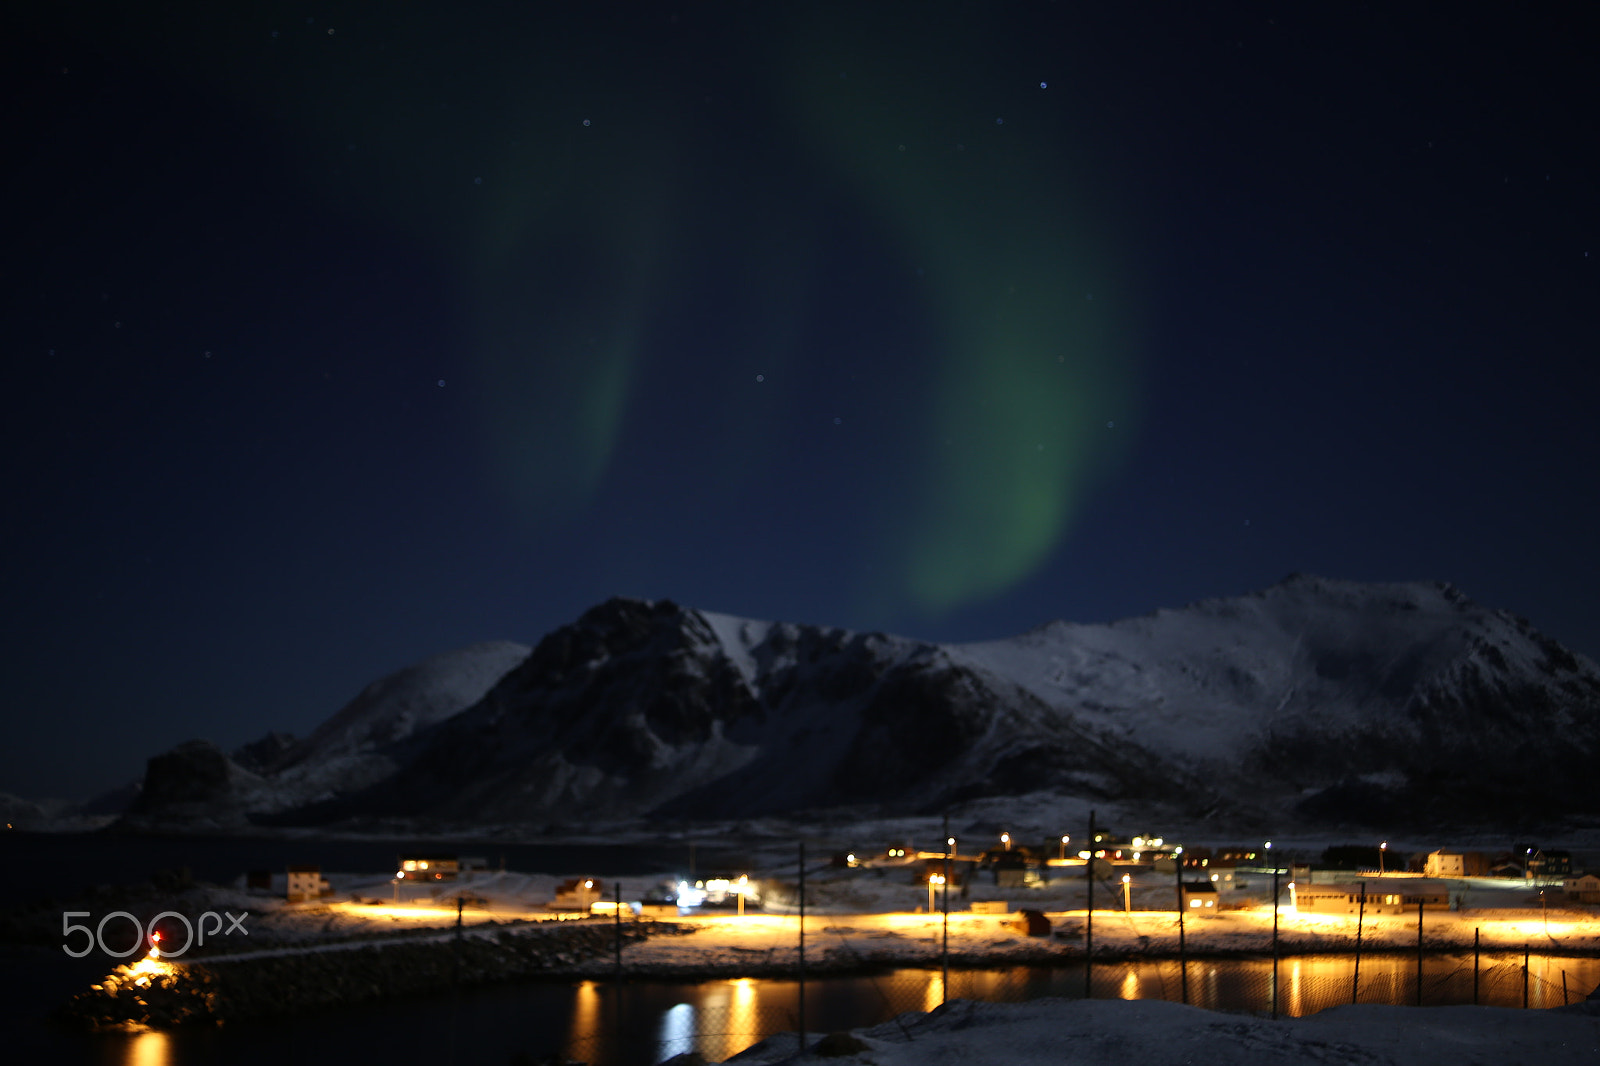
[206,829,1600,968]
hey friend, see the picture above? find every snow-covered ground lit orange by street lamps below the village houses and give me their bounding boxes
[219,866,1600,975]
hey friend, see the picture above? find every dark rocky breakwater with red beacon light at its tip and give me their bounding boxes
[61,922,678,1029]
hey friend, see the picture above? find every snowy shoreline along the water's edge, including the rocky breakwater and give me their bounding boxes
[64,912,1600,1029]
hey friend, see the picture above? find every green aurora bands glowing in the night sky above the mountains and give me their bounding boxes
[78,5,1136,616]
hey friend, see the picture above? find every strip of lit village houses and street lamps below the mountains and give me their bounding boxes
[256,831,1600,917]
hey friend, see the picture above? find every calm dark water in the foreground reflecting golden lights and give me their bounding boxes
[12,951,1600,1066]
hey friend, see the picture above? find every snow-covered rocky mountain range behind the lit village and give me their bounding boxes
[121,575,1600,824]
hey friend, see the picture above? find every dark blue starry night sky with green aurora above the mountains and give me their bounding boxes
[0,0,1600,797]
